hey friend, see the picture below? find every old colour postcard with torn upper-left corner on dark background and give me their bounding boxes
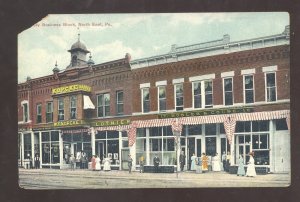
[16,12,291,189]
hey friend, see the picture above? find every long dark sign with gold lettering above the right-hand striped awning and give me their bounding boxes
[158,107,253,119]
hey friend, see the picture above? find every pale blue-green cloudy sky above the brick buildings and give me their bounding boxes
[18,12,290,83]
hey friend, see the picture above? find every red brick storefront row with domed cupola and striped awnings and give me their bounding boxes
[18,26,290,172]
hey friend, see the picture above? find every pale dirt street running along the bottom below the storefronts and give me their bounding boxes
[19,168,290,189]
